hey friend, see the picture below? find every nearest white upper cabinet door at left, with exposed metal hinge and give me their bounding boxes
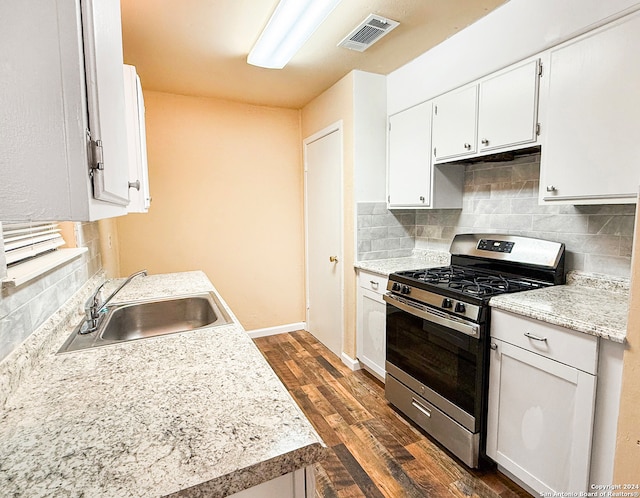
[81,0,129,206]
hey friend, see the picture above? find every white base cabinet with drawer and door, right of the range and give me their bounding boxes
[487,309,598,493]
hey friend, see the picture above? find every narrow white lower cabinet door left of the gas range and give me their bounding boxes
[357,287,387,381]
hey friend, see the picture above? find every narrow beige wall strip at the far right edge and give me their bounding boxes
[613,196,640,482]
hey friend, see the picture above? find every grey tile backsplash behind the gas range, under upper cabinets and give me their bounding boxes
[357,153,635,277]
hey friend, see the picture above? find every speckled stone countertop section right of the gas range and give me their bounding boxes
[490,272,629,343]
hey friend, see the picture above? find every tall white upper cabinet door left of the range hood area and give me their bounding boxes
[388,102,431,207]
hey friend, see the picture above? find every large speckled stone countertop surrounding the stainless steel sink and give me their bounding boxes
[0,272,325,497]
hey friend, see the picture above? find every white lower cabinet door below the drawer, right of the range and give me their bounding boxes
[487,338,596,493]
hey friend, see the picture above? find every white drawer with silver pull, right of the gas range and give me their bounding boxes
[491,309,598,375]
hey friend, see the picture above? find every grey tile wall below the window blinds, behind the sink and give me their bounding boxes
[0,222,102,361]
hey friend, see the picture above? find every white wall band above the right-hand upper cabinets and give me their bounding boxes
[387,0,640,114]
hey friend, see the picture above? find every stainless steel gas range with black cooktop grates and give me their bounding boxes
[384,234,565,467]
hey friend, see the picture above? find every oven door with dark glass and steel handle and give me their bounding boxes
[384,294,485,433]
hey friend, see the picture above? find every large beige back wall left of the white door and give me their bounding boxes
[117,92,304,330]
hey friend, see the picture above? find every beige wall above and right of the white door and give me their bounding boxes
[302,73,356,358]
